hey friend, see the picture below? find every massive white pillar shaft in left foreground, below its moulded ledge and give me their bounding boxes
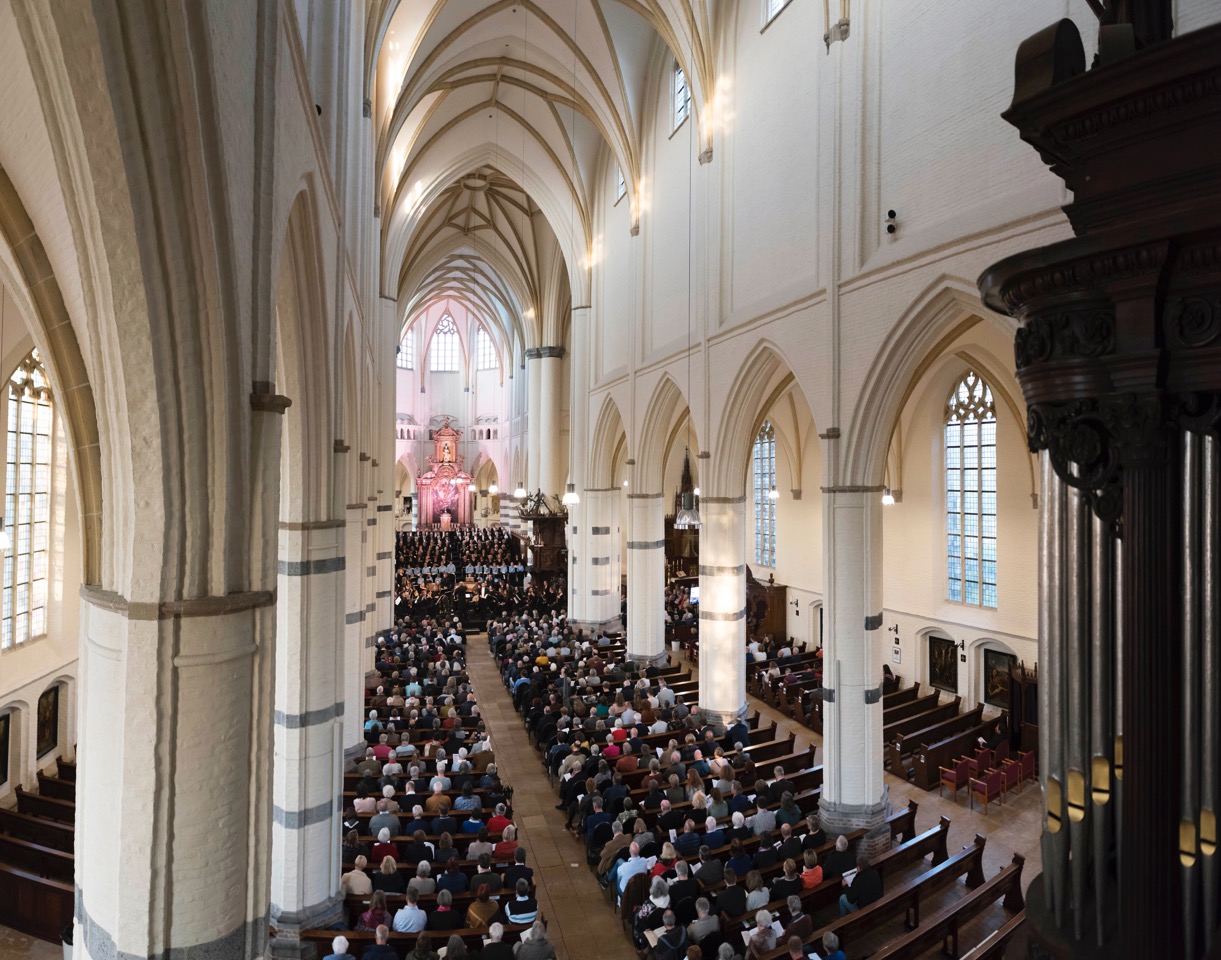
[76,586,275,960]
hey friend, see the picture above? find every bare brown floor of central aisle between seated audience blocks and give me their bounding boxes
[466,634,636,960]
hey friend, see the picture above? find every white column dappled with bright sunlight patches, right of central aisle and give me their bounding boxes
[700,497,746,725]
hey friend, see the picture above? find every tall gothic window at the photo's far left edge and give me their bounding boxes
[0,349,55,650]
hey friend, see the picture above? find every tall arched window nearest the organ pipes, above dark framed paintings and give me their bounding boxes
[945,370,996,607]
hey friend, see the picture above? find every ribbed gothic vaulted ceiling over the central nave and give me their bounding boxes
[365,0,722,351]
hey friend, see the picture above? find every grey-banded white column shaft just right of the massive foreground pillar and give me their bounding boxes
[270,520,346,956]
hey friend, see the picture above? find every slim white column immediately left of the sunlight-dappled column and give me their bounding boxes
[628,493,665,661]
